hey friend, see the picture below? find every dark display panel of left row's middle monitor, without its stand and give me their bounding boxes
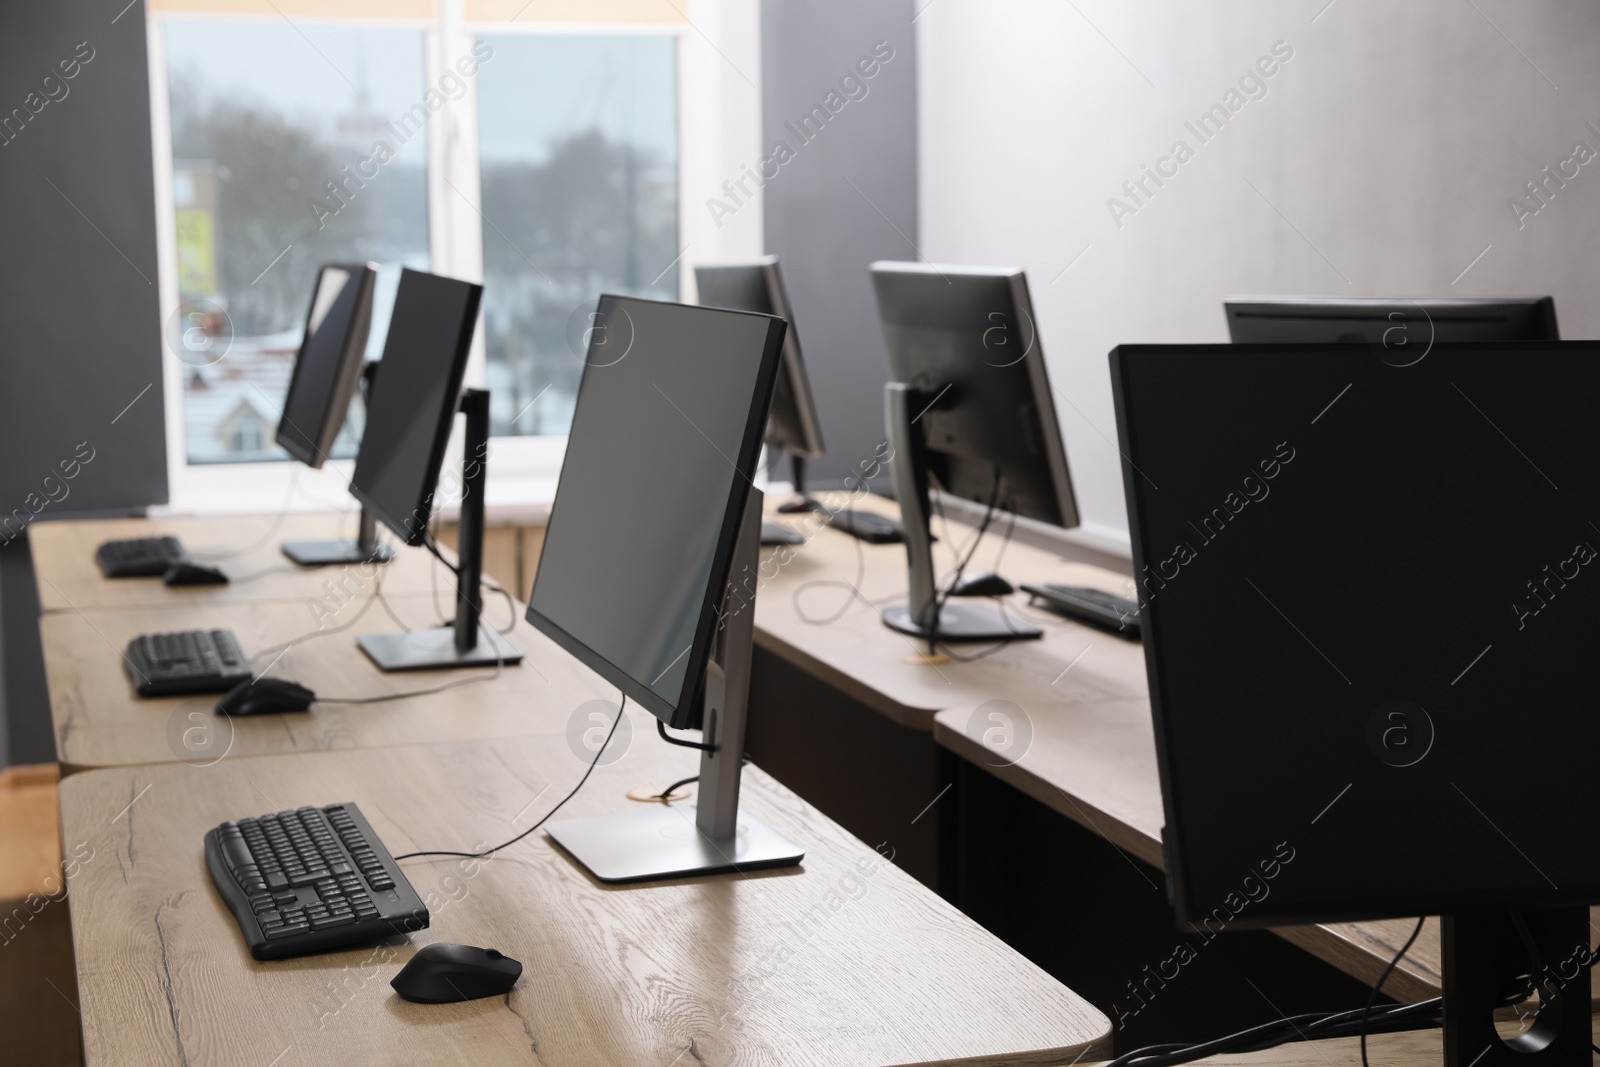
[350,270,483,545]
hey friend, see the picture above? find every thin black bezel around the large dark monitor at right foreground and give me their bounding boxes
[1107,341,1600,929]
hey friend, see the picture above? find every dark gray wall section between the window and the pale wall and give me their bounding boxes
[762,0,918,486]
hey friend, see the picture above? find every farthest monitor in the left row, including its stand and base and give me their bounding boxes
[268,262,394,566]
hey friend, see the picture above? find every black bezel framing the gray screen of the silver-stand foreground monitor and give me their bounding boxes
[523,293,789,729]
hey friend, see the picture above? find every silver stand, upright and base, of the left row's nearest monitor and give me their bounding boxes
[547,488,805,881]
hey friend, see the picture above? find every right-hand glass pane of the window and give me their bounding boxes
[478,34,682,435]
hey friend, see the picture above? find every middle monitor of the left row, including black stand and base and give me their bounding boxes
[350,269,522,670]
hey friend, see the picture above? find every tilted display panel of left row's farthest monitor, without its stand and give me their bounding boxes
[277,264,378,467]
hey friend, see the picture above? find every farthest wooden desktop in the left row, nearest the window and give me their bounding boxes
[27,512,454,613]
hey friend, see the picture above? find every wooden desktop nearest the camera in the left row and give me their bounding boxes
[61,739,1109,1067]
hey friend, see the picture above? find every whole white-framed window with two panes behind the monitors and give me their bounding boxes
[147,0,762,510]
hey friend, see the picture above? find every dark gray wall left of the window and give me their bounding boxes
[0,0,166,763]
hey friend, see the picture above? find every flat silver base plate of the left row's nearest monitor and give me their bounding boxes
[547,805,805,883]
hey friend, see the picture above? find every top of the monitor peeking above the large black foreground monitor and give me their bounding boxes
[1222,296,1560,347]
